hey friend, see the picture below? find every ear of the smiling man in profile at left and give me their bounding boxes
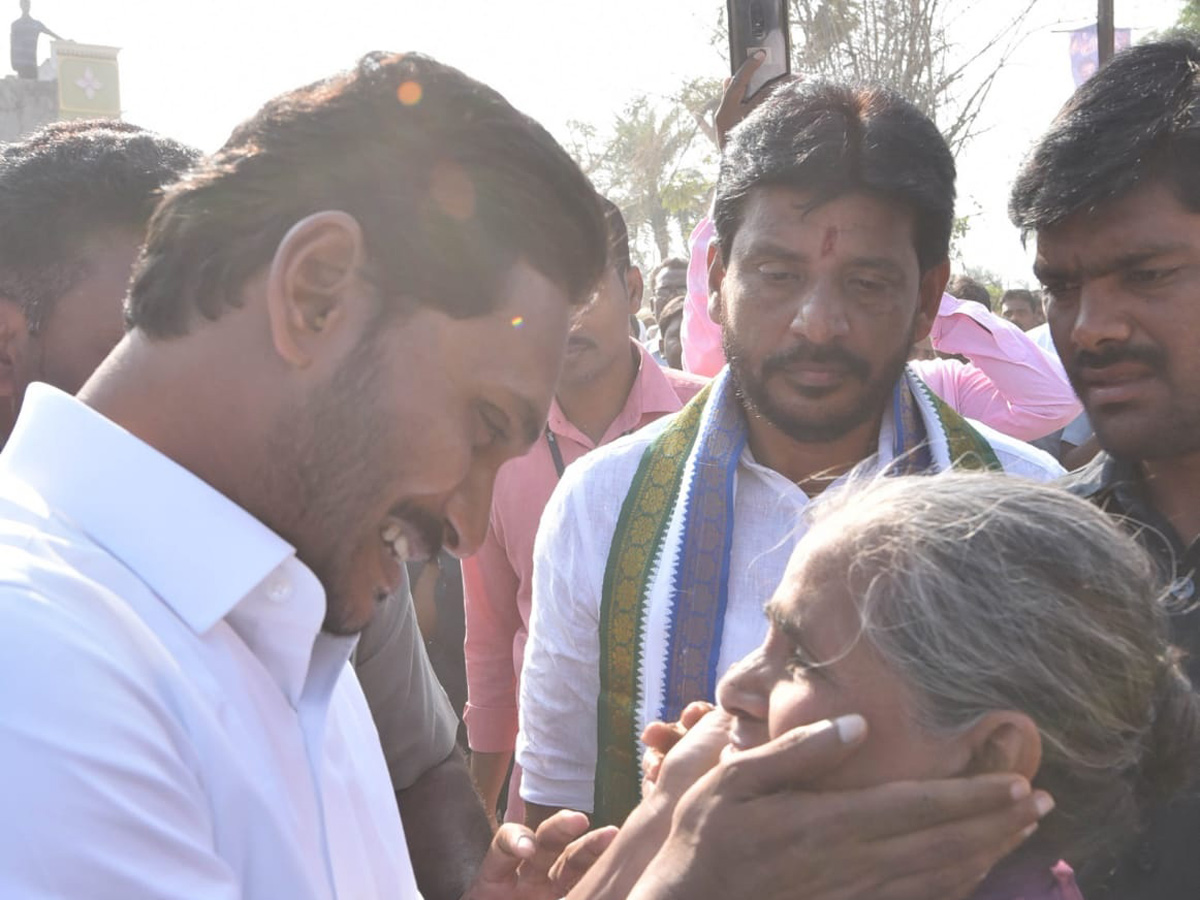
[266,210,374,368]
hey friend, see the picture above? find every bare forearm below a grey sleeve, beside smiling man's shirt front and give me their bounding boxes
[396,748,492,900]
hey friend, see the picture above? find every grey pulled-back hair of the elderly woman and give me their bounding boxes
[802,473,1200,883]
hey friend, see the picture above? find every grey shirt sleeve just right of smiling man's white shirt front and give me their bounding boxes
[354,580,458,791]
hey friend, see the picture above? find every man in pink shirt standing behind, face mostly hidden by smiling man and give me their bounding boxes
[462,202,704,822]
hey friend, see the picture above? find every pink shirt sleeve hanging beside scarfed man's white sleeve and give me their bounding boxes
[462,516,522,754]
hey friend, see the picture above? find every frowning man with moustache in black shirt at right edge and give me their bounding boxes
[1009,38,1200,900]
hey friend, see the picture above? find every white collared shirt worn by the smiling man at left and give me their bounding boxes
[0,385,418,900]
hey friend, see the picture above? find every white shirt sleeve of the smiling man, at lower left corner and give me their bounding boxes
[0,588,242,900]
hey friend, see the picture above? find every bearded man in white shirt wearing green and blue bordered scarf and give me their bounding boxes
[517,83,1061,824]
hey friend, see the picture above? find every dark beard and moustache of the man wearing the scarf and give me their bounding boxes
[721,323,916,444]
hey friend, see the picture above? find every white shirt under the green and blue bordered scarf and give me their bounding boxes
[516,398,1062,812]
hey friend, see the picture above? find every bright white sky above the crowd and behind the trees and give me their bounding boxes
[10,0,1181,284]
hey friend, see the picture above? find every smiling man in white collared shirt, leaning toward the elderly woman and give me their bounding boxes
[0,54,605,900]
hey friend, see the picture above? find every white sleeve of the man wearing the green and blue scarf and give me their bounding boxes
[517,463,612,812]
